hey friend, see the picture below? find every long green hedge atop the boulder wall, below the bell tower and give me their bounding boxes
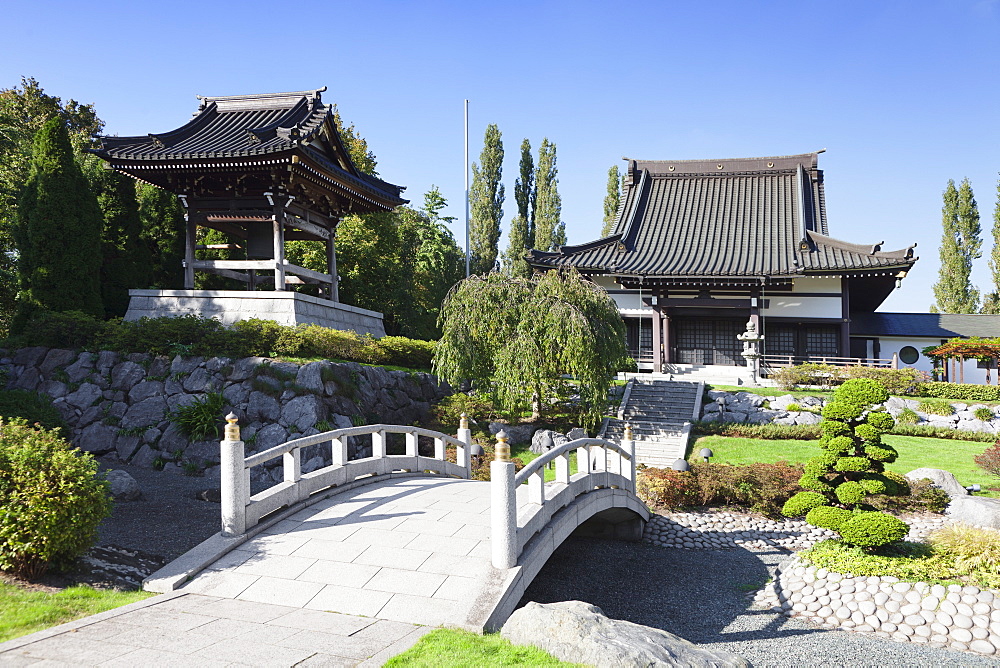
[6,311,435,370]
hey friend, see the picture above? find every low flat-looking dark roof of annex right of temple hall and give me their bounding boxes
[851,313,1000,339]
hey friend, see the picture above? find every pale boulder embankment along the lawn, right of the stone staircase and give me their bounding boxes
[701,390,1000,433]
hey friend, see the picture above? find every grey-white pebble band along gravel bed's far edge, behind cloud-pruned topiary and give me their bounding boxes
[643,510,945,551]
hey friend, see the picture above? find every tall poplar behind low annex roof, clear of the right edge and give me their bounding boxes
[931,178,982,313]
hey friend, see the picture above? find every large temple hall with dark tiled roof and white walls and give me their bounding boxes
[528,153,917,378]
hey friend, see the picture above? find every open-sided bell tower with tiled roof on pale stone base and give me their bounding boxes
[94,88,407,335]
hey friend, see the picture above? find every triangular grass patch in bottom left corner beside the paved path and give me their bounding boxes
[0,582,155,642]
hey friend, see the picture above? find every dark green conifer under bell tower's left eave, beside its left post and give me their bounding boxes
[136,183,184,290]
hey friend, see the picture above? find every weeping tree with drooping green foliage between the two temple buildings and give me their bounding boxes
[434,269,631,423]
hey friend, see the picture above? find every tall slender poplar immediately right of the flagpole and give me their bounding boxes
[469,123,504,274]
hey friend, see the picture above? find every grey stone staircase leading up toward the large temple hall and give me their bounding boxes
[600,378,705,468]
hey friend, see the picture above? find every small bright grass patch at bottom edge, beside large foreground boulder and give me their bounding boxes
[384,629,579,668]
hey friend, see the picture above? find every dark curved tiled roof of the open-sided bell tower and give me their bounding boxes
[93,87,406,206]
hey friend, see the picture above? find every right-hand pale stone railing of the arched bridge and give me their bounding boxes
[490,425,635,568]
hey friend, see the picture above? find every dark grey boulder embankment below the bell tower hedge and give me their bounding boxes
[0,348,451,480]
